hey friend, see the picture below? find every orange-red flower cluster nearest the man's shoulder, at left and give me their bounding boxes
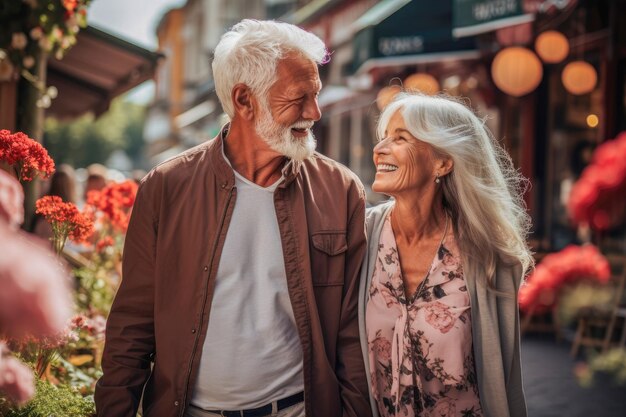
[87,180,138,236]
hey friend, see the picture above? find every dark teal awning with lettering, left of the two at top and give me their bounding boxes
[353,0,476,73]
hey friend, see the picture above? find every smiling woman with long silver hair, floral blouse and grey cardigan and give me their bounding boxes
[359,93,532,417]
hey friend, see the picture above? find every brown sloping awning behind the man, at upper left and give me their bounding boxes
[46,26,162,119]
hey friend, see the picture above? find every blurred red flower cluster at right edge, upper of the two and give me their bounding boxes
[568,132,626,230]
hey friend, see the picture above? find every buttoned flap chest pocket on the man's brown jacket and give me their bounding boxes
[311,231,348,286]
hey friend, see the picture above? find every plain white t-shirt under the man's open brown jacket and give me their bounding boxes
[191,165,304,410]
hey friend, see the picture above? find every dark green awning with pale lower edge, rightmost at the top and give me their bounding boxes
[452,0,535,38]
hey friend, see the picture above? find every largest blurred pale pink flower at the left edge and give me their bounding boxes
[0,222,72,339]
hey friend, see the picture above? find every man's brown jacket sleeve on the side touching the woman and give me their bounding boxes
[336,184,372,417]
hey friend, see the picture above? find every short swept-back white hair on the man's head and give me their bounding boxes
[213,19,328,119]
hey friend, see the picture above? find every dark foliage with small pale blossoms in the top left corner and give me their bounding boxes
[0,0,91,80]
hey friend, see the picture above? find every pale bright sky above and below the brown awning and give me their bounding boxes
[88,0,186,103]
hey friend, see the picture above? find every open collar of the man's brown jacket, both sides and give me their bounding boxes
[207,123,302,188]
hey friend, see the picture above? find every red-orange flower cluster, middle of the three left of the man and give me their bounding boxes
[35,195,93,254]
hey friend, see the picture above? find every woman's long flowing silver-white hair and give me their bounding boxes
[377,93,534,289]
